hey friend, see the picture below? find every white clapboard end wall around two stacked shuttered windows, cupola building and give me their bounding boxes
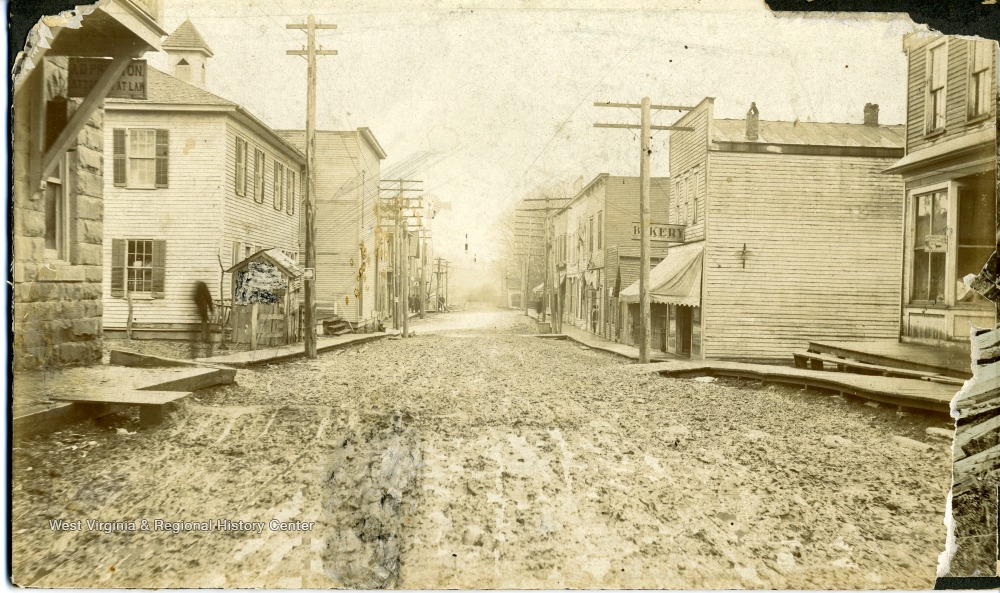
[103,104,230,329]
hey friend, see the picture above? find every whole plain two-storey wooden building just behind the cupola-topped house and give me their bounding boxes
[279,128,392,327]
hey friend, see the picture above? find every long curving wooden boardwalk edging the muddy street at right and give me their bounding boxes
[633,360,958,414]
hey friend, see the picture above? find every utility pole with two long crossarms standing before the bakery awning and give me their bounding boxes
[594,97,694,363]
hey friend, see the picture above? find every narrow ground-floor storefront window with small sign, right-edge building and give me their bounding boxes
[910,190,948,303]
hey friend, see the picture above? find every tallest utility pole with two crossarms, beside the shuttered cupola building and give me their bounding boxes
[288,15,337,358]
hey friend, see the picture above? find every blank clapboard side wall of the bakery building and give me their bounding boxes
[703,152,903,359]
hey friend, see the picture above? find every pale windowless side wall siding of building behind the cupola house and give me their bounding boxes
[280,130,382,323]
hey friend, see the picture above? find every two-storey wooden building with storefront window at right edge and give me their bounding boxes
[887,35,997,344]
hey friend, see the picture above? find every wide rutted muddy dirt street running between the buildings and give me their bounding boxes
[12,310,951,589]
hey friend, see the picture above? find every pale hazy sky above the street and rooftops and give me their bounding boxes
[127,0,915,267]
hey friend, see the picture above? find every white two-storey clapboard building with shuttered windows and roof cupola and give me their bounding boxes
[103,21,305,338]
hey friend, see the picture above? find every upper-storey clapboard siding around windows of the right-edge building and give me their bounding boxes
[906,37,996,153]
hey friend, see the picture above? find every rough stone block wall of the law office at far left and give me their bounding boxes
[12,59,104,370]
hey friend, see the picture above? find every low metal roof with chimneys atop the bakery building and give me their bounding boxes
[712,119,906,148]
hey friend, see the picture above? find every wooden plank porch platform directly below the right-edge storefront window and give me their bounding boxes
[809,340,972,379]
